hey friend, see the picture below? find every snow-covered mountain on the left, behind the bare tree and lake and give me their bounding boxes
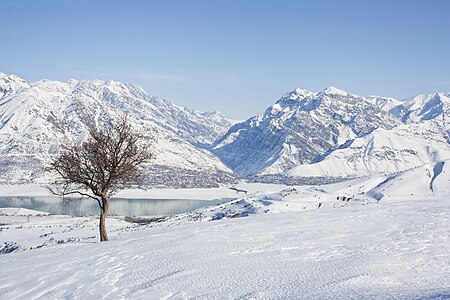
[0,73,234,186]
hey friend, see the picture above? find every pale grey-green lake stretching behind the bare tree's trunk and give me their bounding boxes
[0,196,231,217]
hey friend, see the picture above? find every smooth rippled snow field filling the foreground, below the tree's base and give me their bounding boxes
[0,199,450,299]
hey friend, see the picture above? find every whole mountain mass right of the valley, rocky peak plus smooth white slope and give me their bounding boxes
[211,87,450,183]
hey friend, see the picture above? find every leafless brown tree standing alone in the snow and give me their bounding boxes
[49,117,154,241]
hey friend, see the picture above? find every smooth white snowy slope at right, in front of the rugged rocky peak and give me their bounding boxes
[286,121,450,177]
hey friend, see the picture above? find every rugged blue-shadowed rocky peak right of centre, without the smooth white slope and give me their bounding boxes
[210,87,401,176]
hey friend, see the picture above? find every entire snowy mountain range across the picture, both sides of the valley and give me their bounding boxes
[0,73,450,187]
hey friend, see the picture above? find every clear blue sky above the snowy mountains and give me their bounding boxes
[0,0,450,118]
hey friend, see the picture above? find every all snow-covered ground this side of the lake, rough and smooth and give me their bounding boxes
[0,161,450,299]
